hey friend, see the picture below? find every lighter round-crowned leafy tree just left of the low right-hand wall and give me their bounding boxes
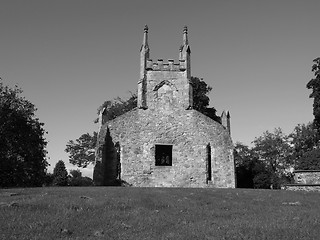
[253,128,293,188]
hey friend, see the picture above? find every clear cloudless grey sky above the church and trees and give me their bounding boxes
[0,0,320,176]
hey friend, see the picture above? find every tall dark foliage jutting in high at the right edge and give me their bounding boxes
[307,58,320,129]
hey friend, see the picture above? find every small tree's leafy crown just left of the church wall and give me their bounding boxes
[65,132,97,168]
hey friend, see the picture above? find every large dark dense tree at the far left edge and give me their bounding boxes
[0,80,48,187]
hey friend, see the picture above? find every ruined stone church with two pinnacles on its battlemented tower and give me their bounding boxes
[93,26,235,188]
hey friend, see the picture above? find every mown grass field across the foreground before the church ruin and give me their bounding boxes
[0,187,320,240]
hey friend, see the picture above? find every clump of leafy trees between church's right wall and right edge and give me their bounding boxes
[234,123,320,188]
